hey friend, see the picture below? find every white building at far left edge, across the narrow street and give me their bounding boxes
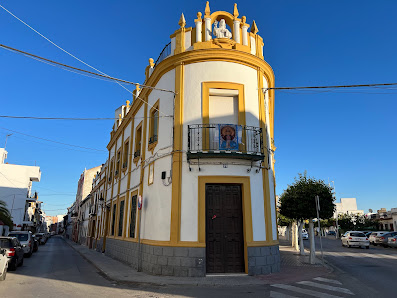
[0,148,42,231]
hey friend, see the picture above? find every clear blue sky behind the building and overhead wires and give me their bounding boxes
[0,0,397,215]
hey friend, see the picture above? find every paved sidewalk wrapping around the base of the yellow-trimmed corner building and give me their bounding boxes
[62,238,331,286]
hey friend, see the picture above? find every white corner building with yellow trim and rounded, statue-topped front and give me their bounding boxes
[95,2,280,276]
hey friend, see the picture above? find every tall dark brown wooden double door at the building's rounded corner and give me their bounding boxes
[205,184,245,273]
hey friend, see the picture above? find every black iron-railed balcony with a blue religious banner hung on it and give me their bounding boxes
[187,124,265,161]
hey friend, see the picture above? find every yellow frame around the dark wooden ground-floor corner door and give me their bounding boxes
[198,176,253,273]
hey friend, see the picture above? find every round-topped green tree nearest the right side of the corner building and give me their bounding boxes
[280,173,335,263]
